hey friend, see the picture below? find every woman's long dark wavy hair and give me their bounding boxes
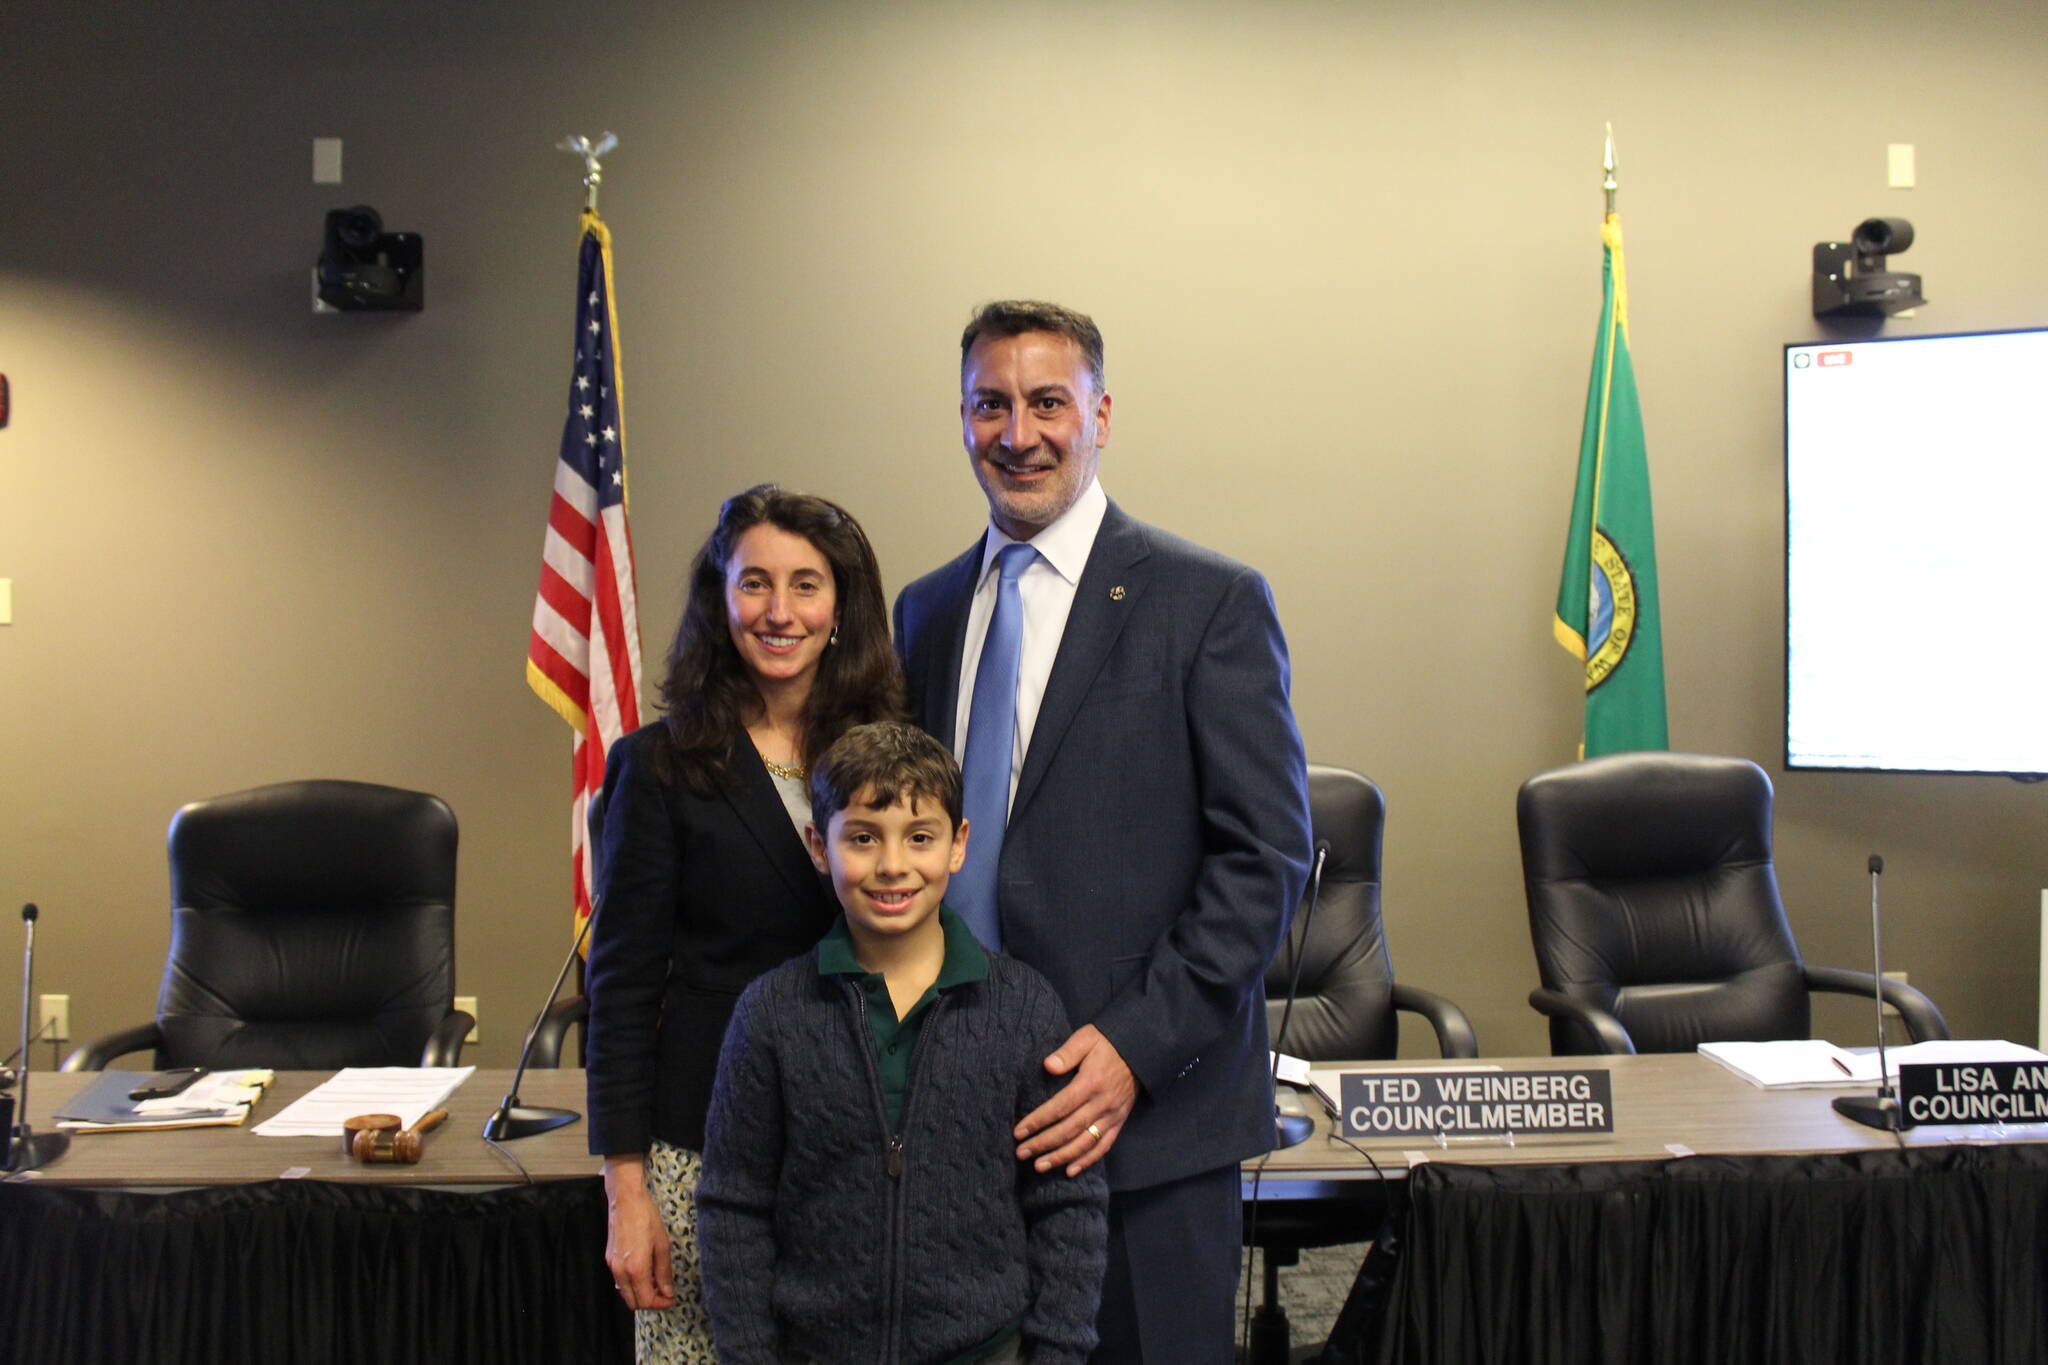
[662,483,905,796]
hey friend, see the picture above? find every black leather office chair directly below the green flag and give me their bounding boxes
[1516,753,1948,1056]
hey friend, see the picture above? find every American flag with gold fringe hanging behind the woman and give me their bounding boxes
[526,213,641,929]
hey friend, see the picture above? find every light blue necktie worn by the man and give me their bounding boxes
[946,544,1038,948]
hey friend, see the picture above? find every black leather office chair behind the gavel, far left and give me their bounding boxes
[63,782,475,1070]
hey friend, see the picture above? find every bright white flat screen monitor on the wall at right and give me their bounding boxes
[1784,329,2048,774]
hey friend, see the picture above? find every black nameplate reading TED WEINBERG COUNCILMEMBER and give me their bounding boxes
[1337,1070,1614,1138]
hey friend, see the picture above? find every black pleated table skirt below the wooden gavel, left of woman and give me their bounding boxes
[0,1179,633,1365]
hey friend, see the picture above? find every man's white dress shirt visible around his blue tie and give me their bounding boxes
[952,479,1110,818]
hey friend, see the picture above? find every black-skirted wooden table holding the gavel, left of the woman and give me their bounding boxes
[0,1070,633,1365]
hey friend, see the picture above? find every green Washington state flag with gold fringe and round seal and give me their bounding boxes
[1552,213,1671,757]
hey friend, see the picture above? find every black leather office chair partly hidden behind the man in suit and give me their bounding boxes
[1245,763,1479,1363]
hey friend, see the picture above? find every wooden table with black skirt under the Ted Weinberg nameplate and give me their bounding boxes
[1262,1054,2048,1365]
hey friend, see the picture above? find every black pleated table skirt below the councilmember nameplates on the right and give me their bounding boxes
[1323,1146,2048,1365]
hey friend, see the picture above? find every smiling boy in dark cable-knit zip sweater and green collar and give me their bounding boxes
[696,722,1108,1365]
